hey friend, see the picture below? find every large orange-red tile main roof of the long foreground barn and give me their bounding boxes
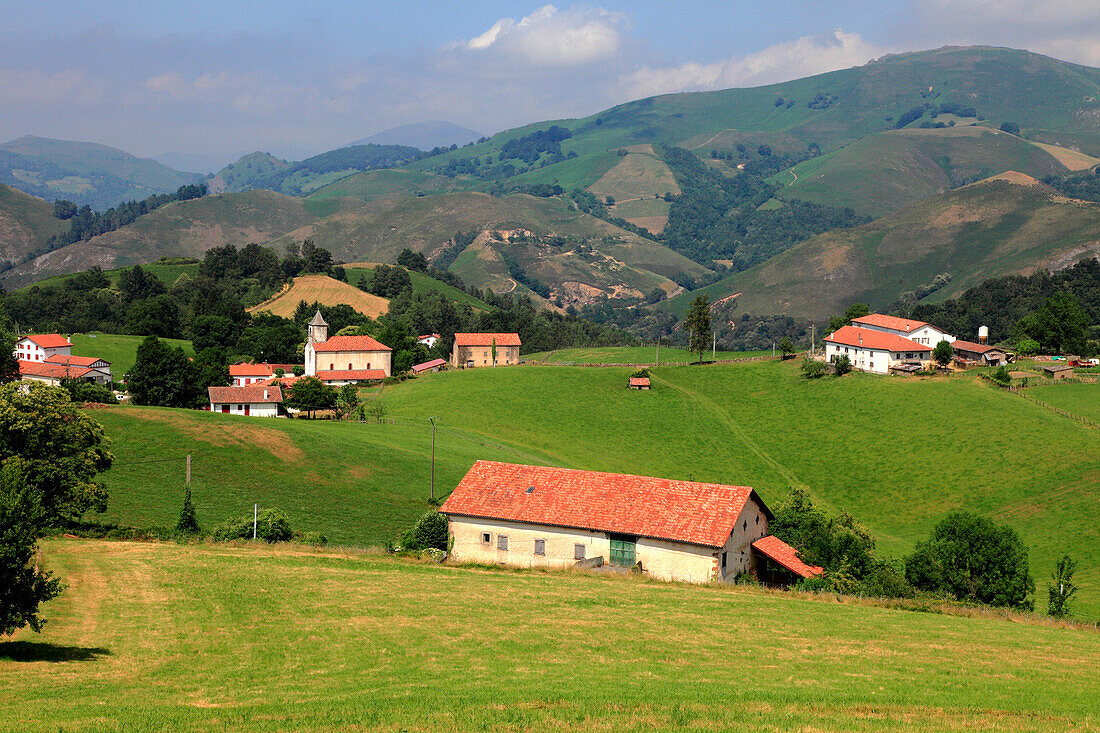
[440,461,771,547]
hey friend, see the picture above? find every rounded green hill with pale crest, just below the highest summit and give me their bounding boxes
[777,125,1070,217]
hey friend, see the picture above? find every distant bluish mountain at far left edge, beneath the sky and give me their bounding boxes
[0,135,198,210]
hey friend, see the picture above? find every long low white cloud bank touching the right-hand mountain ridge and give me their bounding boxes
[623,30,889,97]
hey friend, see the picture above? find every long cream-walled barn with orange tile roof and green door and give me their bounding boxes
[440,461,821,582]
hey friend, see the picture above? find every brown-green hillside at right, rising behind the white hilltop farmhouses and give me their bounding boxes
[668,175,1100,319]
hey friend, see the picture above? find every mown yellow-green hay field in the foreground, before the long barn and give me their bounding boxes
[0,540,1100,733]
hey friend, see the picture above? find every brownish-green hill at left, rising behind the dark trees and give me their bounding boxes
[2,190,323,288]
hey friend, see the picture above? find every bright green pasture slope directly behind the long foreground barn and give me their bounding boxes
[96,360,1100,619]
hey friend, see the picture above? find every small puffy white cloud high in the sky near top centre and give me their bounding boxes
[462,6,623,66]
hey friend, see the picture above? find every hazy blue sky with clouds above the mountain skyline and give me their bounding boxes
[0,0,1100,169]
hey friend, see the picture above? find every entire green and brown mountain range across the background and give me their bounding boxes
[0,47,1100,320]
